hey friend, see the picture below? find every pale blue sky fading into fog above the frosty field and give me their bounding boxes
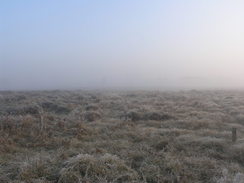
[0,0,244,90]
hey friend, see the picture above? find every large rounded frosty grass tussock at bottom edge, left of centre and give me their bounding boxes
[58,154,138,183]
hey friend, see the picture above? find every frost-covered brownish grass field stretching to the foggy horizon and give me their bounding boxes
[0,91,244,183]
